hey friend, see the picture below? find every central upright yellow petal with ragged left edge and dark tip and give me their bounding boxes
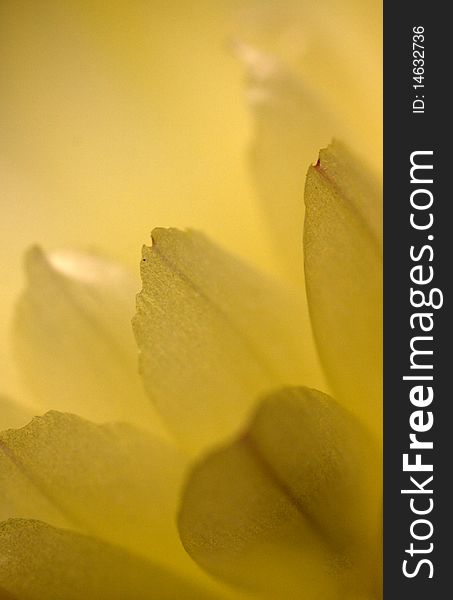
[134,229,320,450]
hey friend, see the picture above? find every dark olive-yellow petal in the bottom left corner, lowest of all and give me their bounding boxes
[0,519,223,600]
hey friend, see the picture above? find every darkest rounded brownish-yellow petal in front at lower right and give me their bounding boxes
[179,388,380,599]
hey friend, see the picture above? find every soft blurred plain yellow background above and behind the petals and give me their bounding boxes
[0,0,382,404]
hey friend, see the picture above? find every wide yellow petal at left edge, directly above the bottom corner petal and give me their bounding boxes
[0,412,188,563]
